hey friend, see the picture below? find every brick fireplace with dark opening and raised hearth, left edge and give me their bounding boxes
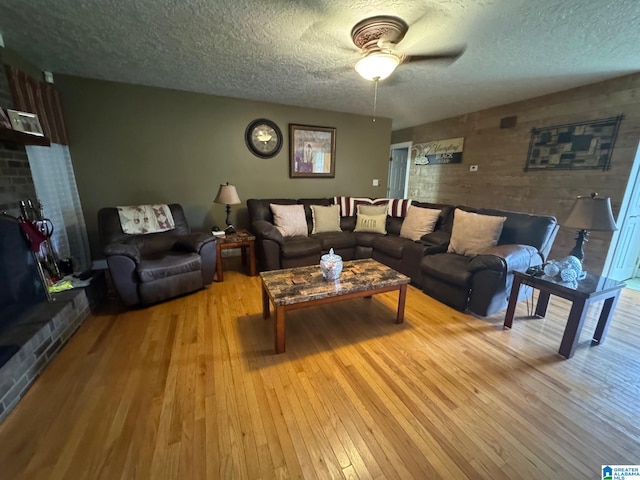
[0,48,99,422]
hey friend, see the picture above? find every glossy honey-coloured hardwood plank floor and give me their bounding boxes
[0,258,640,480]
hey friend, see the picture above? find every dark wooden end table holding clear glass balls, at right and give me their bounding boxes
[504,272,625,358]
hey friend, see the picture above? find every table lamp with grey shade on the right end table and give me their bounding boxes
[563,193,618,261]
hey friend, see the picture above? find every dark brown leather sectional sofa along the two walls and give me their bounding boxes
[247,198,558,316]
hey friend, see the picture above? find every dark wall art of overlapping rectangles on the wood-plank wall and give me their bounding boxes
[524,115,622,172]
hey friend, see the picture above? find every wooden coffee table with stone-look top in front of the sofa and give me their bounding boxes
[260,259,411,353]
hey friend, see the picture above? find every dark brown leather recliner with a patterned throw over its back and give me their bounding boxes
[98,204,216,306]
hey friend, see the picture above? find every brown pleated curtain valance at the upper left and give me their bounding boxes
[6,65,69,145]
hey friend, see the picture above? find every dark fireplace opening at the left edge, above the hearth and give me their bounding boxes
[0,214,49,366]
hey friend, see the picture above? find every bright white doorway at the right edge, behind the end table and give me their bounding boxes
[603,139,640,290]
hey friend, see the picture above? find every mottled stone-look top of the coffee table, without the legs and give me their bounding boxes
[260,259,411,306]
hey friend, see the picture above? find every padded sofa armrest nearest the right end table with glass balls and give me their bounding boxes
[469,245,542,272]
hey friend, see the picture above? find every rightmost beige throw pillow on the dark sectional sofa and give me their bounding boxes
[447,208,507,257]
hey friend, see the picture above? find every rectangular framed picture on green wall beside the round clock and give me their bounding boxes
[289,123,336,178]
